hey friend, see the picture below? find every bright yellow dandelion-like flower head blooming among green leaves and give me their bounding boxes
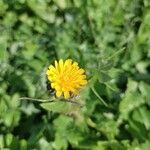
[46,59,87,99]
